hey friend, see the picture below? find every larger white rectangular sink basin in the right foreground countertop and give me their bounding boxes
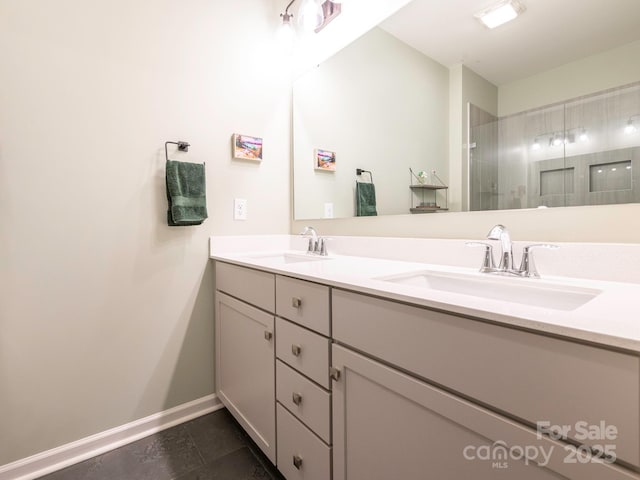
[379,271,601,310]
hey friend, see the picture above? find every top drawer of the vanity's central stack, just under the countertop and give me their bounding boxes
[276,276,330,336]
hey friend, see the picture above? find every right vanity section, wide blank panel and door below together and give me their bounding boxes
[332,289,640,480]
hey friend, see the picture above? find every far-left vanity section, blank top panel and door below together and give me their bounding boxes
[215,262,276,463]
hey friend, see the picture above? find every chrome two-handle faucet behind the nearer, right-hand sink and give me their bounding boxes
[467,224,558,278]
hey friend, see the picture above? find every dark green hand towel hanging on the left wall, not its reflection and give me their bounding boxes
[166,160,207,227]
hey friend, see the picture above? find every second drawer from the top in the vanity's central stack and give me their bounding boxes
[276,318,329,389]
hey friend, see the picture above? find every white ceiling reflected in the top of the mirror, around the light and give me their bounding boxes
[380,0,640,85]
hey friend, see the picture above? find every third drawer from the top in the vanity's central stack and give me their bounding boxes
[276,360,331,443]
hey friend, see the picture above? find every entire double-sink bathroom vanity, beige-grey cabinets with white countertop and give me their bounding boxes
[211,235,640,480]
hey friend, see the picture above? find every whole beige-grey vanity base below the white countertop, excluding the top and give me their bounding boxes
[216,262,640,480]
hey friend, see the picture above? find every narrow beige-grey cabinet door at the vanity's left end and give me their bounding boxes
[216,292,276,463]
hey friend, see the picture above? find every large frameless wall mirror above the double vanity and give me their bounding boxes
[293,0,640,220]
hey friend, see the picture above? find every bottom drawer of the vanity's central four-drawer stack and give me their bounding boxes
[277,404,331,480]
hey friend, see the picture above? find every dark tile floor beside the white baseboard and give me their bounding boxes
[41,409,284,480]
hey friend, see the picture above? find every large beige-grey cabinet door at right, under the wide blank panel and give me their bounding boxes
[332,345,640,480]
